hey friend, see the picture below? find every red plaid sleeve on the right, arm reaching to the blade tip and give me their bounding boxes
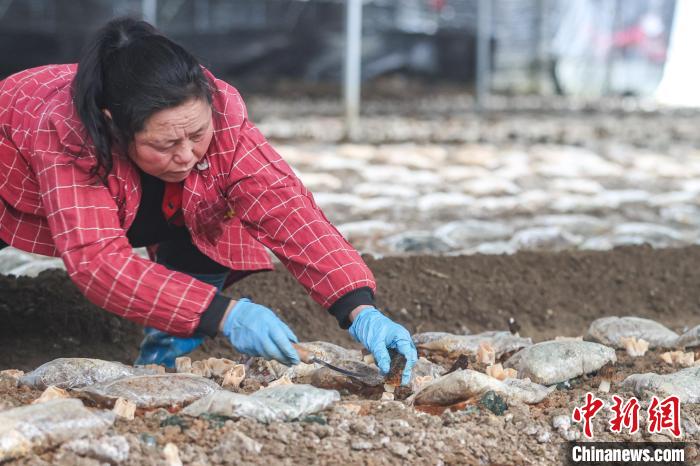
[228,119,376,309]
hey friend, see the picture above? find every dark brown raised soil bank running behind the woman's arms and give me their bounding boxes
[0,246,700,370]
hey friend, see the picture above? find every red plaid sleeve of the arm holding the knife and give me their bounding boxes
[31,114,216,336]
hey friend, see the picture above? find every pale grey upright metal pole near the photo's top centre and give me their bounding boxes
[343,0,363,140]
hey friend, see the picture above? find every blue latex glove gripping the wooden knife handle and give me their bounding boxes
[222,298,300,365]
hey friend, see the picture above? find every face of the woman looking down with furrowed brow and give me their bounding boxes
[129,99,214,182]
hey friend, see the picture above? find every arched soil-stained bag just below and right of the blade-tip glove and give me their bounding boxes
[413,369,554,406]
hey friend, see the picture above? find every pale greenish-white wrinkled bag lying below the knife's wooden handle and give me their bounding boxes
[182,384,340,423]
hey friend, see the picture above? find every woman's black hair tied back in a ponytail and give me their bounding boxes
[72,18,212,182]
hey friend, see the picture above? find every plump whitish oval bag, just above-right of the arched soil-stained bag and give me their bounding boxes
[505,340,617,385]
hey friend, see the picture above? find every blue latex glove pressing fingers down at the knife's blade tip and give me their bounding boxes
[349,307,418,385]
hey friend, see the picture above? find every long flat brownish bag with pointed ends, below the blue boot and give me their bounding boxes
[77,374,221,409]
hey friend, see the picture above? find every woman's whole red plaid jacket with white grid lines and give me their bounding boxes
[0,65,375,336]
